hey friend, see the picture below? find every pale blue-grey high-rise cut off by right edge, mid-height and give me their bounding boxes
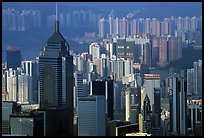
[193,60,202,97]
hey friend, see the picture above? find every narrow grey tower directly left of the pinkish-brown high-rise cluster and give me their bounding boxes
[151,37,159,66]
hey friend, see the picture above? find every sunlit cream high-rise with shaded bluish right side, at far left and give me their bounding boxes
[17,73,33,104]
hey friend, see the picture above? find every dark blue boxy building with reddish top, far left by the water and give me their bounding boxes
[6,47,21,69]
